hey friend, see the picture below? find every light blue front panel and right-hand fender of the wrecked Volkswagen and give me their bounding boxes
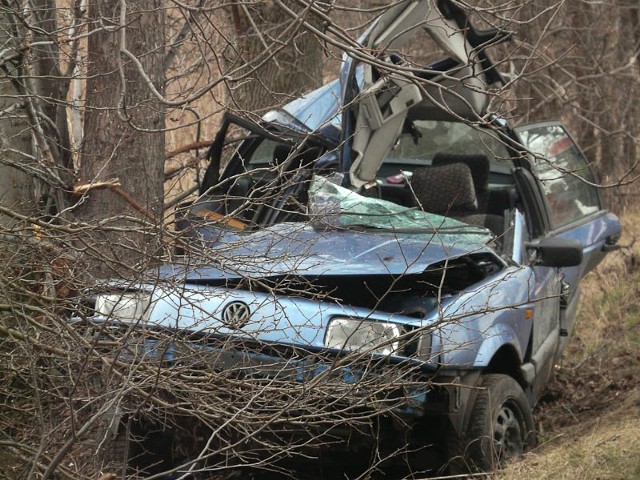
[134,253,535,375]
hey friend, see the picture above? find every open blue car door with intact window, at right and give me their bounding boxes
[516,123,620,359]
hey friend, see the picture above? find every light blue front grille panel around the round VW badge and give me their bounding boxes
[102,283,436,368]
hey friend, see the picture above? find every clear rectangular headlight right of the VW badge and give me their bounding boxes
[324,317,404,355]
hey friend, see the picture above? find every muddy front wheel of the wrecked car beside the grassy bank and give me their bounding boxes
[457,374,535,471]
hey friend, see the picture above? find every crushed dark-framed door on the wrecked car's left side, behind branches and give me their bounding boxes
[176,114,336,236]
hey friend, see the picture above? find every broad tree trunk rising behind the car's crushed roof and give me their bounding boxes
[226,0,323,113]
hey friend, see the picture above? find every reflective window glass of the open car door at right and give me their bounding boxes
[519,124,601,228]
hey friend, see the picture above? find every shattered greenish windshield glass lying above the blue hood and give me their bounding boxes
[309,176,492,244]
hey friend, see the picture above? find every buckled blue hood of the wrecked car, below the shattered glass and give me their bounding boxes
[160,223,489,282]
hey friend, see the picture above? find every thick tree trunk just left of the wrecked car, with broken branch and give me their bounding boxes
[78,0,165,276]
